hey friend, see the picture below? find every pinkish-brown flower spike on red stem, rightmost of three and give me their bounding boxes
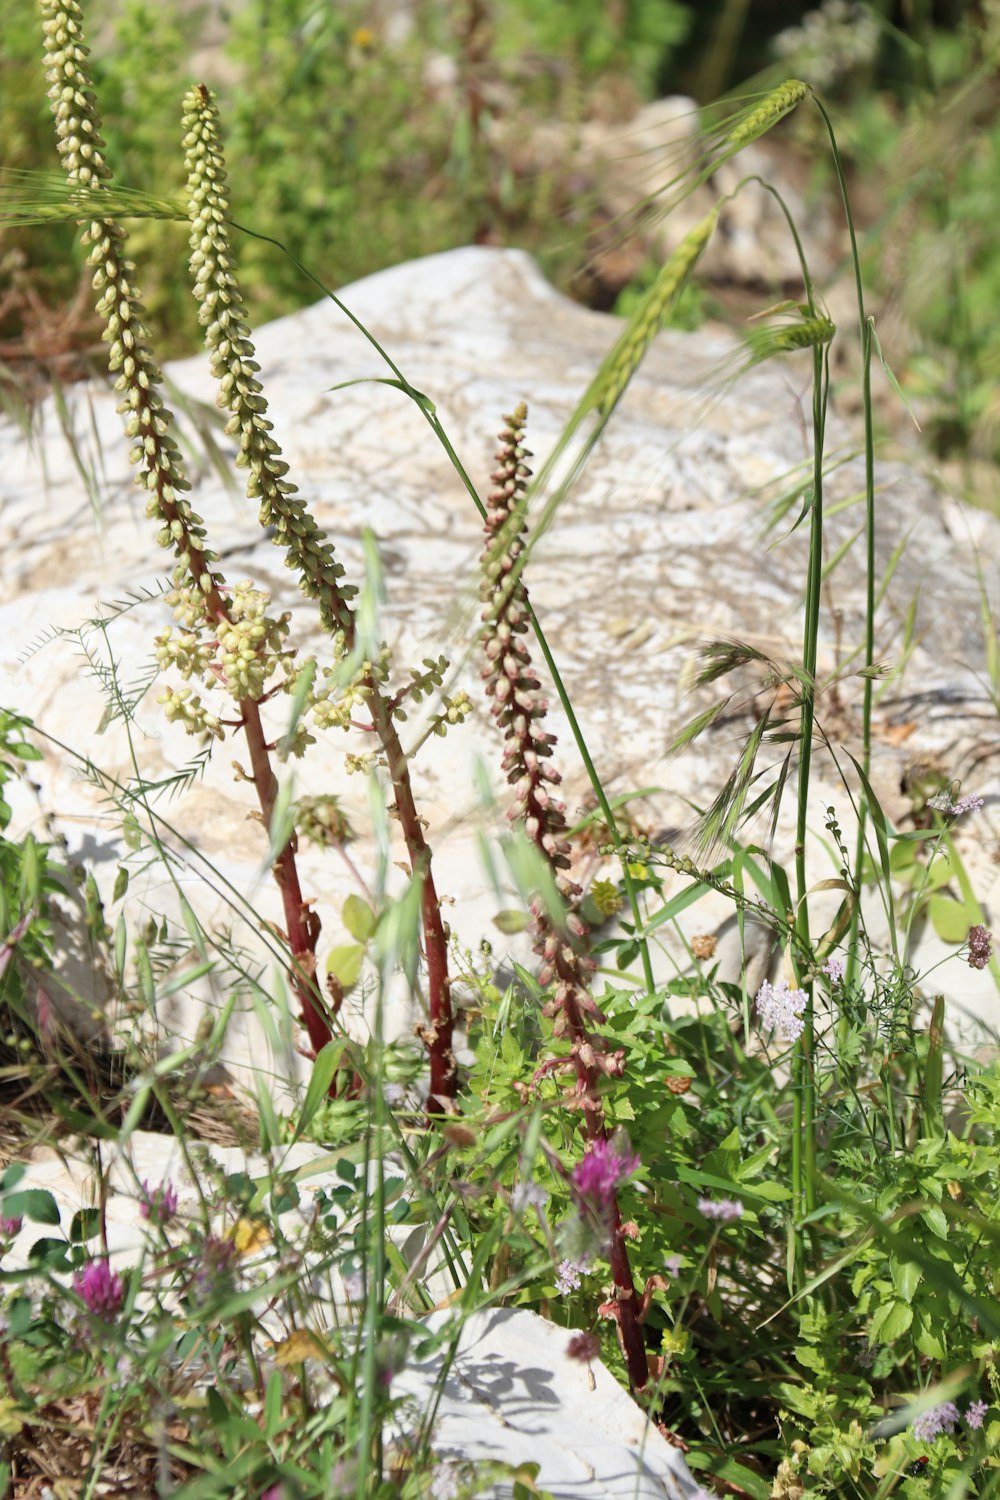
[481,402,649,1389]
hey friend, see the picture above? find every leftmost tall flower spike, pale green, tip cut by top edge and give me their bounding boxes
[40,0,330,1052]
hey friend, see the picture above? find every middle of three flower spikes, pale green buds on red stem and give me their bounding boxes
[183,86,462,1107]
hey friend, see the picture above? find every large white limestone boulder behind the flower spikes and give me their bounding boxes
[0,248,1000,1086]
